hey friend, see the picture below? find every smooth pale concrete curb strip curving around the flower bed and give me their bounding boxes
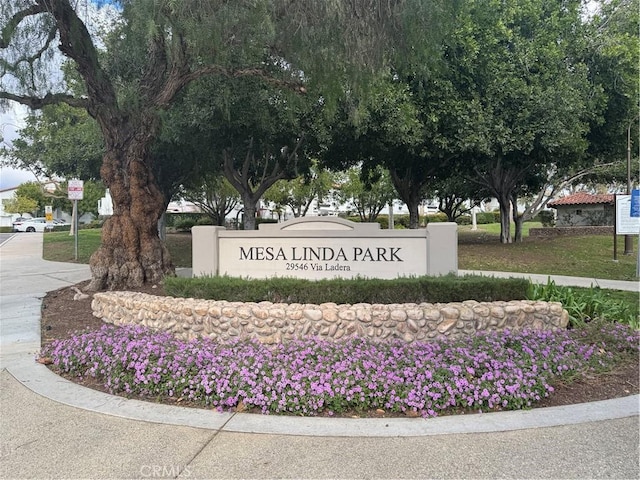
[6,354,640,437]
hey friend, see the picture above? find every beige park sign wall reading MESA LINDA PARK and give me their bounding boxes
[192,217,458,280]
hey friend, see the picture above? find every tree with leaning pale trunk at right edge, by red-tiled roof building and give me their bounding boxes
[504,0,640,241]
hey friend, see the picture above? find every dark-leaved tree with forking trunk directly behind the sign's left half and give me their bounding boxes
[178,75,321,230]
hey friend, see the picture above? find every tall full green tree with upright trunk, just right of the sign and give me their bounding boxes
[447,0,597,243]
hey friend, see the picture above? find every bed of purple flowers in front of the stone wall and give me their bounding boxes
[41,324,640,417]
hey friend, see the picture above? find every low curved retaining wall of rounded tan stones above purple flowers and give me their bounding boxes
[92,292,569,344]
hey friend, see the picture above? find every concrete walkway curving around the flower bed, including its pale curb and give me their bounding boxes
[0,234,640,479]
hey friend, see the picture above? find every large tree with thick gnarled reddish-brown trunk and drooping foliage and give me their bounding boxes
[0,0,448,290]
